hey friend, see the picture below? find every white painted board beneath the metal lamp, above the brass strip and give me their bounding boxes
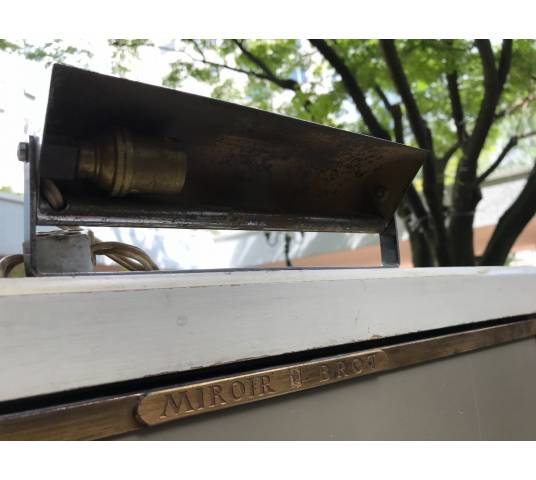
[0,268,536,400]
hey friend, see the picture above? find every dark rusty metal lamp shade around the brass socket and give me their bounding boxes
[37,65,426,232]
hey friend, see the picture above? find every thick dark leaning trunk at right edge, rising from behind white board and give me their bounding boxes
[481,160,536,265]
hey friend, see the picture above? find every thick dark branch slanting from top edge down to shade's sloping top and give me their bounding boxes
[309,39,389,140]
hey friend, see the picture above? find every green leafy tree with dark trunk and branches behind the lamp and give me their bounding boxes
[4,39,536,266]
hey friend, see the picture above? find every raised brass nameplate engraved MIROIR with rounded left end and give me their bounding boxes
[137,350,388,425]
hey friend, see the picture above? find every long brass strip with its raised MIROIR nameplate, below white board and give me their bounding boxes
[0,319,536,440]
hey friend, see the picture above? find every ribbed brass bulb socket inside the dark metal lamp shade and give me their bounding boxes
[78,131,187,197]
